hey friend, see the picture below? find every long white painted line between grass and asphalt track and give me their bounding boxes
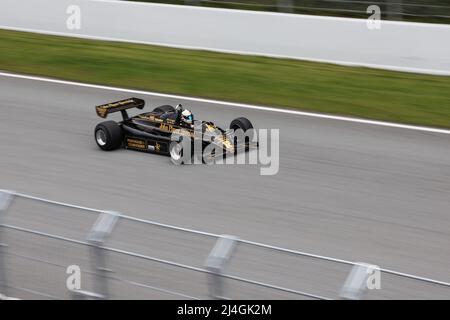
[0,72,450,135]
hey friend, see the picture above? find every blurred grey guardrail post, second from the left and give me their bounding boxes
[85,211,119,299]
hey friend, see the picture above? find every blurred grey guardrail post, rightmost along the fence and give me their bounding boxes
[340,262,380,300]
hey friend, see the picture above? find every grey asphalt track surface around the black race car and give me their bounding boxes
[0,77,450,299]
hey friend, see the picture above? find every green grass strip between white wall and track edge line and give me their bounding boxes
[0,30,450,128]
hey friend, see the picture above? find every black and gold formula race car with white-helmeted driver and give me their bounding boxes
[95,98,258,164]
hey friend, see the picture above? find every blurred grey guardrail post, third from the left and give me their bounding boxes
[205,235,238,299]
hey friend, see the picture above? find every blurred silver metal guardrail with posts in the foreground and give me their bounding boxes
[0,190,450,300]
